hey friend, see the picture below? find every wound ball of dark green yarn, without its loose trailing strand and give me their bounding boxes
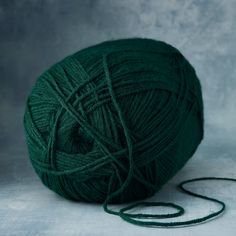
[24,39,203,203]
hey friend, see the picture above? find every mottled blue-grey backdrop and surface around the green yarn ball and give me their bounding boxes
[0,0,236,235]
